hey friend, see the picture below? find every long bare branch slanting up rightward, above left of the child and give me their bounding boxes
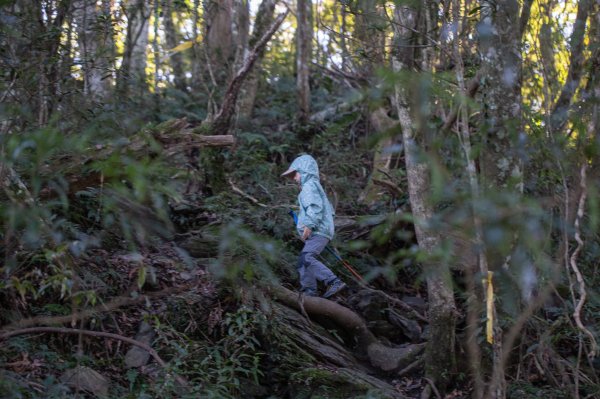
[210,9,289,133]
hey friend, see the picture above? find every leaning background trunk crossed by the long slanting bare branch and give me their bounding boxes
[238,0,275,118]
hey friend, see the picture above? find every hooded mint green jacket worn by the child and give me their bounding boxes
[288,155,335,240]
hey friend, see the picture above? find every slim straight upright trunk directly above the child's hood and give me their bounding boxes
[296,0,313,124]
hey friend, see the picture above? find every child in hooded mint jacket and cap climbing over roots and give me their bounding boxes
[281,155,346,298]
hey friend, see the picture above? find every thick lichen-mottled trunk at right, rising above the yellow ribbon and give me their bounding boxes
[478,0,523,399]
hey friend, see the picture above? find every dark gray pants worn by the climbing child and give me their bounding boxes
[298,234,337,296]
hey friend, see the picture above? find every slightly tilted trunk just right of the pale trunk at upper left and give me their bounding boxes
[118,0,151,93]
